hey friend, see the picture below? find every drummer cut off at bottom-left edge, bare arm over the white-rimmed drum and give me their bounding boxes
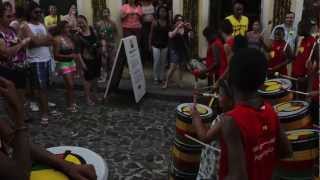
[0,77,97,180]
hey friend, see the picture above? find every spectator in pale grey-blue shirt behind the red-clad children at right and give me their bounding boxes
[271,12,298,53]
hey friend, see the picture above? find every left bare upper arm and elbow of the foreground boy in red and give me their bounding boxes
[222,117,248,180]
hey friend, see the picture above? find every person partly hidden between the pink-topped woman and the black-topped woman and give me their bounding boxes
[142,0,155,62]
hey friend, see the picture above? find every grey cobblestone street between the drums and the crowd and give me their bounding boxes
[26,90,178,180]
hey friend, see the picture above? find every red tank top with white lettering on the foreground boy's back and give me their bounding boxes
[219,103,279,180]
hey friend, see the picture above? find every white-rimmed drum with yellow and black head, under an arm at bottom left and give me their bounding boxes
[30,146,108,180]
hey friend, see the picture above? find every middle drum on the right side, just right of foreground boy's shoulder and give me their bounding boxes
[274,101,312,131]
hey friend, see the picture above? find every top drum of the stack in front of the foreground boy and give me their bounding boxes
[176,103,214,145]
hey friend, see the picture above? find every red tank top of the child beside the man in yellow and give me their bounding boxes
[206,38,227,77]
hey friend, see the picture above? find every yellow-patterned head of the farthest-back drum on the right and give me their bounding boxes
[258,78,292,95]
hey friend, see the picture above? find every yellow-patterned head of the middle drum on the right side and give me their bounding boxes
[274,101,310,119]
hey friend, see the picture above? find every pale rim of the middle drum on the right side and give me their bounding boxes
[273,100,310,120]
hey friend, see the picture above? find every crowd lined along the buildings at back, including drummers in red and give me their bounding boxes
[0,0,319,125]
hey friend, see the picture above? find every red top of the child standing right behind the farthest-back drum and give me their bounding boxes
[268,41,288,75]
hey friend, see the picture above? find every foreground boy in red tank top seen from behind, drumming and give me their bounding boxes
[193,49,291,180]
